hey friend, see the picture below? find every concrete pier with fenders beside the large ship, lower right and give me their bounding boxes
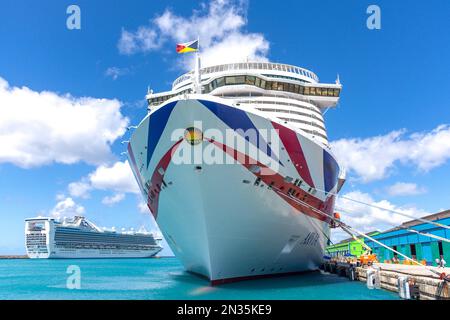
[356,263,450,300]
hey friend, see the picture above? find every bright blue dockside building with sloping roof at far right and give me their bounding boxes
[365,210,450,266]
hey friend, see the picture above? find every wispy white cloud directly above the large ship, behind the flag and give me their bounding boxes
[118,0,269,69]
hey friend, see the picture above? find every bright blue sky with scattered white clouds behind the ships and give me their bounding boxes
[0,0,450,254]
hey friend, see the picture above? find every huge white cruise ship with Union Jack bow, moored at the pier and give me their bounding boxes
[128,60,344,284]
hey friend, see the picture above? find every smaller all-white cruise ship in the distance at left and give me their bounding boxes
[25,216,162,259]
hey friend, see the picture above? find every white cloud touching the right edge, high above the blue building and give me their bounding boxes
[331,125,450,182]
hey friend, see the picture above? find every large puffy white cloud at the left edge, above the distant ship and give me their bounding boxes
[0,77,129,168]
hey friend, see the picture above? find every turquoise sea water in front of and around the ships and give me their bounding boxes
[0,258,397,300]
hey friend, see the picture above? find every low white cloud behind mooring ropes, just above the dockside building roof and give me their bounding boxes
[333,191,430,239]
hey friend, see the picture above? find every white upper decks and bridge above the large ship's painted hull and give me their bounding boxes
[147,62,342,145]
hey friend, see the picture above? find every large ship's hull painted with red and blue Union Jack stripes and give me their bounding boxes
[128,95,339,284]
